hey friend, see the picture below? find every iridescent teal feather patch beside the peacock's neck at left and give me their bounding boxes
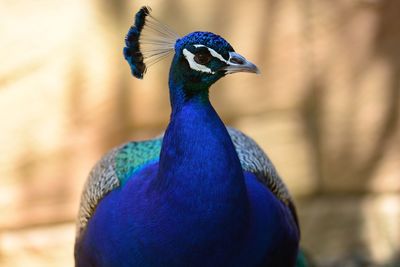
[115,138,162,186]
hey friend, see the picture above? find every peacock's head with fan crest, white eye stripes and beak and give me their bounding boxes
[124,7,259,89]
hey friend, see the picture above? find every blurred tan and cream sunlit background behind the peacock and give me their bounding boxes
[0,0,400,267]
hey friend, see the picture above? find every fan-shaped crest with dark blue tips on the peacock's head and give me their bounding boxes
[124,6,179,79]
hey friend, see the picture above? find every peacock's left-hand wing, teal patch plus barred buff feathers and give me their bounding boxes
[77,137,162,237]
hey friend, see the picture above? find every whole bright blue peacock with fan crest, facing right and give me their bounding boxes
[75,7,306,267]
